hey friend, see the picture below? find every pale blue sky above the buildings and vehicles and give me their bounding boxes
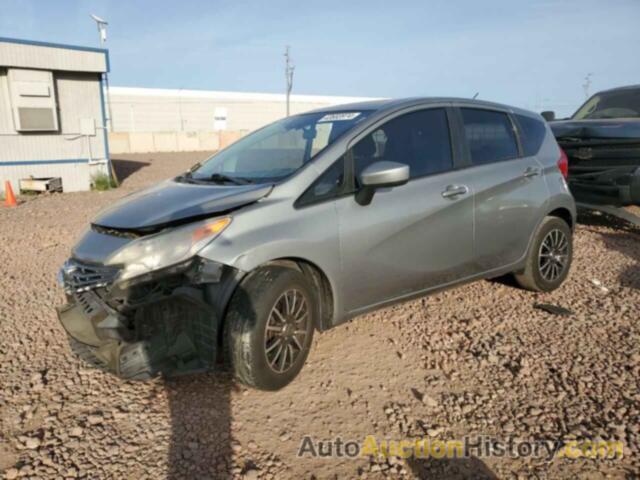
[0,0,640,113]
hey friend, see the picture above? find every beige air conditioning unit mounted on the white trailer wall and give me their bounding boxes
[7,68,58,132]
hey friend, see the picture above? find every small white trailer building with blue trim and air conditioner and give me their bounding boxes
[0,37,110,193]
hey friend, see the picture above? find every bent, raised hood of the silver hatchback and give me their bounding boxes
[93,180,273,232]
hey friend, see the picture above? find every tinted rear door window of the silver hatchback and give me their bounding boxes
[460,108,518,165]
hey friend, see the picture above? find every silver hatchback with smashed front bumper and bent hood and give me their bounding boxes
[58,98,576,390]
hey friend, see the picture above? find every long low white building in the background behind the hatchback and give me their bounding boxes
[109,87,378,153]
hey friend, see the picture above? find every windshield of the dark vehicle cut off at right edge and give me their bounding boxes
[571,88,640,120]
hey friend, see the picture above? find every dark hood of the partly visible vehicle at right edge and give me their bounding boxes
[549,118,640,139]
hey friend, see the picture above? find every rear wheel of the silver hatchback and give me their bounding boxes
[514,217,573,292]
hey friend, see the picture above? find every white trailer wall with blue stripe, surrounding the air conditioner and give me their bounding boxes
[0,69,108,192]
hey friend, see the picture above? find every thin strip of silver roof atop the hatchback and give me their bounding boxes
[307,97,531,113]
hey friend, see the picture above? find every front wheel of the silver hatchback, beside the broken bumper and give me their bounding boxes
[224,267,318,391]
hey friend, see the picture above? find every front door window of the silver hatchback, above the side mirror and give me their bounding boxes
[353,108,453,179]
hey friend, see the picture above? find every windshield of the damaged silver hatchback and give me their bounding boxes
[187,111,370,183]
